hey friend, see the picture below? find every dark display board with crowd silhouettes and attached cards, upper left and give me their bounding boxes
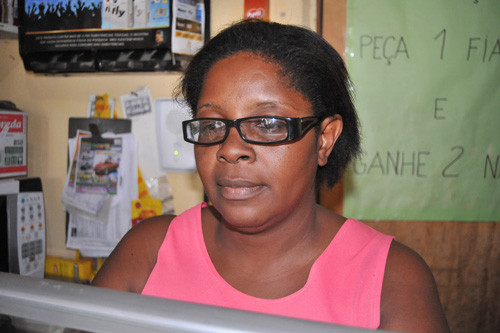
[19,0,210,73]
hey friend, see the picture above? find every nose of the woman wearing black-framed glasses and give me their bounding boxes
[217,127,255,164]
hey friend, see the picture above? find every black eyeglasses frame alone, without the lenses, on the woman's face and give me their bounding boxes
[182,116,325,146]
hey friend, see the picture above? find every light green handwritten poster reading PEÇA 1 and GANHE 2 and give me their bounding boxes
[344,0,500,221]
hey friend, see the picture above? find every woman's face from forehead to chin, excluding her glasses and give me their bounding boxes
[195,53,328,233]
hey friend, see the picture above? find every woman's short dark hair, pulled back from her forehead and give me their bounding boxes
[180,20,360,187]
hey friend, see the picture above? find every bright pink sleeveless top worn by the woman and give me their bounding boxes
[142,204,393,329]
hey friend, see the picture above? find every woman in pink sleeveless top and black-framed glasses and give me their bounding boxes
[93,21,448,332]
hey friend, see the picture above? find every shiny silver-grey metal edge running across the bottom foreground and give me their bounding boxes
[0,273,371,333]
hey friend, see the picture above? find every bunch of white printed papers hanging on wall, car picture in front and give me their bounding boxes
[63,133,138,257]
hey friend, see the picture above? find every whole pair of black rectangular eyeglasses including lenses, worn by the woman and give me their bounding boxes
[182,116,323,145]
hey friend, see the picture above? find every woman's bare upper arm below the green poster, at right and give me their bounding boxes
[380,242,449,333]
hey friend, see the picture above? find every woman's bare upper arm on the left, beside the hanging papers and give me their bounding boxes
[92,215,173,293]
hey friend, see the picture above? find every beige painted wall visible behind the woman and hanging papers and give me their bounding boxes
[0,0,316,257]
